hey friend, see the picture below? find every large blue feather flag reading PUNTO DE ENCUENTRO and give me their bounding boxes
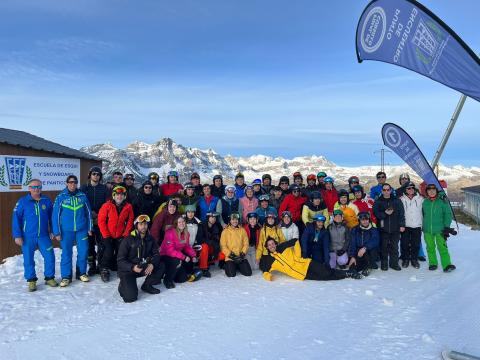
[356,0,480,101]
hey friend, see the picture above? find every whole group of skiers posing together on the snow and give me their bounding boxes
[12,167,455,302]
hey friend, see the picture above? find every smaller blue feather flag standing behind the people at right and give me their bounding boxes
[382,123,443,190]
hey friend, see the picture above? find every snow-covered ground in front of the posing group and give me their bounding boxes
[0,226,480,360]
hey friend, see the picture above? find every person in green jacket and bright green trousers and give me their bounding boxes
[422,184,455,272]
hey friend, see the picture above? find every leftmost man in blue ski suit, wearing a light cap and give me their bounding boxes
[12,179,58,291]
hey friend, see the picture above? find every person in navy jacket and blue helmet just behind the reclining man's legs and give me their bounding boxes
[300,214,330,264]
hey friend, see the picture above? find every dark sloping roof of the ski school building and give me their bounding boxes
[0,128,102,161]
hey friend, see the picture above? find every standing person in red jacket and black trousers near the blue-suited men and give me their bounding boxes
[98,186,134,282]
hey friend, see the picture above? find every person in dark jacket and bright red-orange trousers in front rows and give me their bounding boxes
[198,212,225,278]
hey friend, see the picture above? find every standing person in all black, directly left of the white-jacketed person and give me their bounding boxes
[373,183,405,271]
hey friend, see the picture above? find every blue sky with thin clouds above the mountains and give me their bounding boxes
[0,0,480,166]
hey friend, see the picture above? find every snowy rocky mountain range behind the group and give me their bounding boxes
[80,138,480,201]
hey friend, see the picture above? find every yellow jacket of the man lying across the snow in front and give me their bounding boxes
[263,240,312,280]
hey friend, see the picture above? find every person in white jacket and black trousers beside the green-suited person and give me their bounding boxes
[400,182,424,269]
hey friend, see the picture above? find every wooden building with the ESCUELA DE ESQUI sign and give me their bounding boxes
[0,128,102,261]
